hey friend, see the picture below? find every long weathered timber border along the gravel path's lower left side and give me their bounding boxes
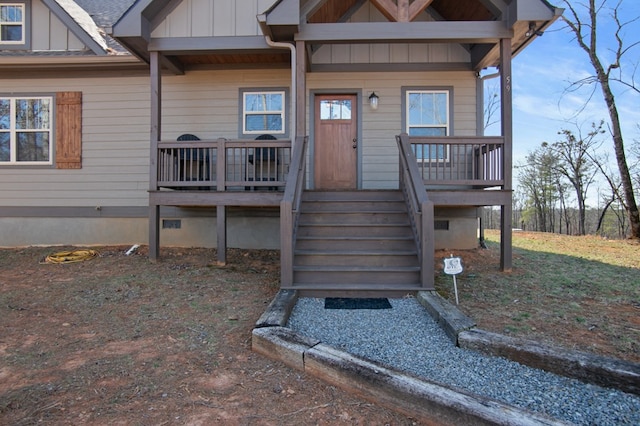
[252,327,566,426]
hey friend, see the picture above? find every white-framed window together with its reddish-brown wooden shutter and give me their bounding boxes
[0,92,82,169]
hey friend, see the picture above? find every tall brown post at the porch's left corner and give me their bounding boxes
[149,52,162,260]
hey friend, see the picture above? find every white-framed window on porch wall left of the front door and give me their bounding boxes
[242,91,286,135]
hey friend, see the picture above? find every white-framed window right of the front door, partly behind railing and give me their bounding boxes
[404,90,450,162]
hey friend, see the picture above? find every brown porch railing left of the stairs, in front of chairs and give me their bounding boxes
[156,138,291,191]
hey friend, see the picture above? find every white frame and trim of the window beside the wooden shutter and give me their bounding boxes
[0,93,57,168]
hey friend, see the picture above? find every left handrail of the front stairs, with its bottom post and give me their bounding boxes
[280,136,309,287]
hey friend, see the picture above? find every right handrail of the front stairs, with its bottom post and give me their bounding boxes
[396,133,435,289]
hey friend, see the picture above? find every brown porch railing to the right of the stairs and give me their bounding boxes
[409,136,504,188]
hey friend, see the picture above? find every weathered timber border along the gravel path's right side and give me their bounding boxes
[416,291,640,395]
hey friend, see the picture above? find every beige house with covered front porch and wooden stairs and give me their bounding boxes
[0,0,561,294]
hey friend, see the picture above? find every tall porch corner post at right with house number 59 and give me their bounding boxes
[500,38,513,271]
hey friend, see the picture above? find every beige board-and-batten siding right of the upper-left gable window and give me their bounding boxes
[31,0,87,51]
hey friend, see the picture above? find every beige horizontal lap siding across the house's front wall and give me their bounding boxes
[0,70,476,207]
